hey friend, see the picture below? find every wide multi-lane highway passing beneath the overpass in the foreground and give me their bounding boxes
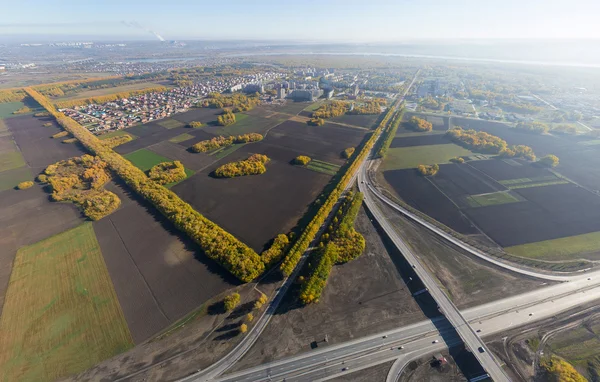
[217,278,600,382]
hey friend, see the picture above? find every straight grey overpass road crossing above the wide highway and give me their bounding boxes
[358,166,509,382]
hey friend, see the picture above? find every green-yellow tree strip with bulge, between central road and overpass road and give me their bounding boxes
[300,193,365,304]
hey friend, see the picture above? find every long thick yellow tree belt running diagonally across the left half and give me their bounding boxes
[26,88,265,282]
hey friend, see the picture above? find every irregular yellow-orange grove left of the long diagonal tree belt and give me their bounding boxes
[38,154,121,220]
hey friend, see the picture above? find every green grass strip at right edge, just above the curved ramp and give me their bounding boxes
[504,232,600,260]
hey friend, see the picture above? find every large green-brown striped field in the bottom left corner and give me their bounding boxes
[0,223,133,381]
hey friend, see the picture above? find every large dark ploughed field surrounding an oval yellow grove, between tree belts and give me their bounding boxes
[172,142,331,251]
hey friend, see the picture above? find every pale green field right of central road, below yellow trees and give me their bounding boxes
[383,143,473,171]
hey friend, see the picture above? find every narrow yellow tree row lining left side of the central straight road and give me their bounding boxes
[279,98,395,276]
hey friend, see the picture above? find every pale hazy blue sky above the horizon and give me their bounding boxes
[0,0,600,42]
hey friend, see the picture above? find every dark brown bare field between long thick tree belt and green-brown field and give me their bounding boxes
[94,184,235,343]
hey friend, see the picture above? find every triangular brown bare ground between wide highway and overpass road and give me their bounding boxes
[234,209,425,370]
